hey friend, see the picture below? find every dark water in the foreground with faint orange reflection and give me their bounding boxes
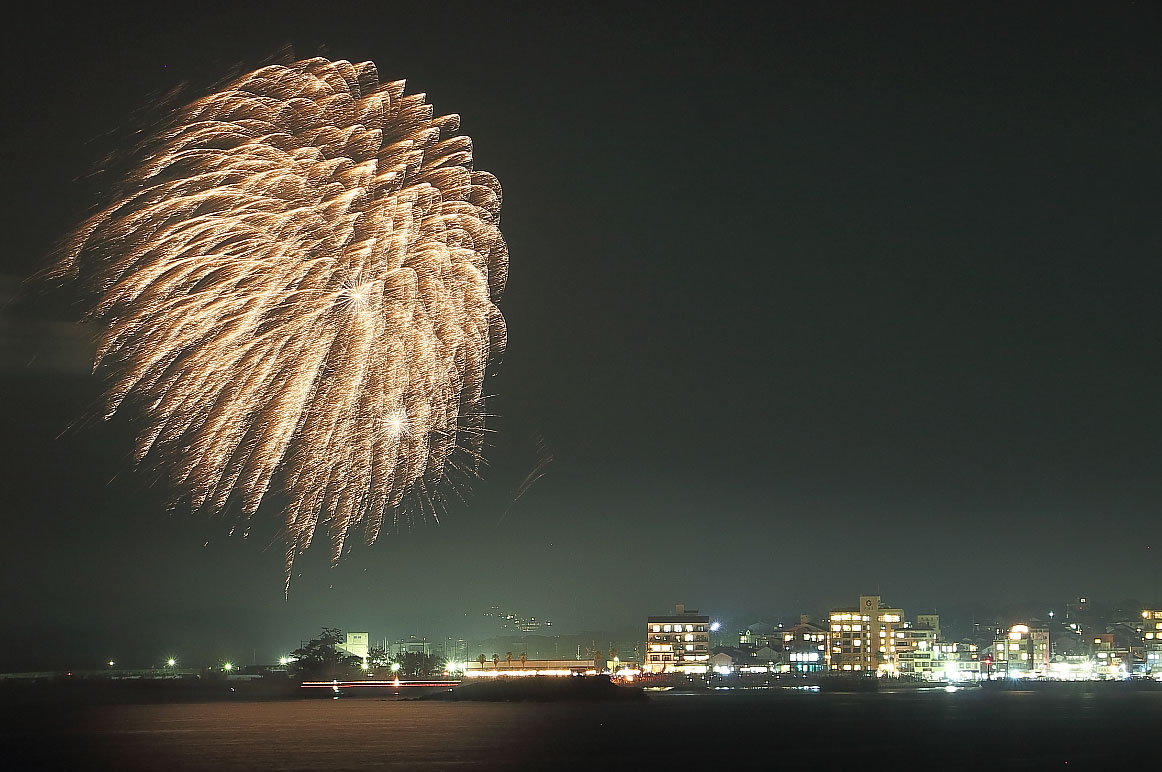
[0,689,1162,772]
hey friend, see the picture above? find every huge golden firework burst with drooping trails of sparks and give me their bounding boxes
[51,58,508,585]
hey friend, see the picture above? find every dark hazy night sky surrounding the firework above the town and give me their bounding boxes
[0,2,1162,666]
